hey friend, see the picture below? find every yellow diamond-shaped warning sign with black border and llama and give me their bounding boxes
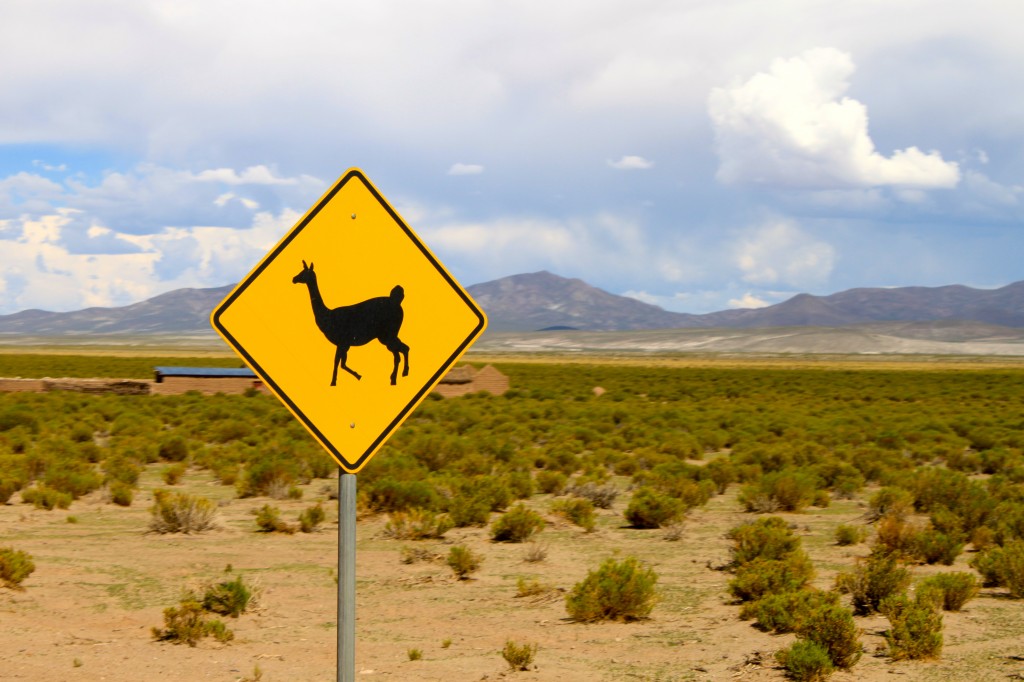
[212,169,486,473]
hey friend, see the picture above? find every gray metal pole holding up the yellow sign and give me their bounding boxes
[338,470,355,682]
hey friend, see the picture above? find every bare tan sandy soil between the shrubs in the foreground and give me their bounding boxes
[0,468,1024,682]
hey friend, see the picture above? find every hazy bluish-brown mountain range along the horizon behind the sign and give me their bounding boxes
[0,272,1024,337]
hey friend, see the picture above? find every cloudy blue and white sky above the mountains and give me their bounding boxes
[0,0,1024,314]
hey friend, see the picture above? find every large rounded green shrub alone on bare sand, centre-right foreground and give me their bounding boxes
[565,557,657,623]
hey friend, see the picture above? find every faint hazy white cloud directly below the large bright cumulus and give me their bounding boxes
[734,219,836,287]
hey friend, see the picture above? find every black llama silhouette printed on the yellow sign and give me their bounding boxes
[292,261,409,386]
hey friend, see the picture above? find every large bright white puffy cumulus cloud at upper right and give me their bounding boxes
[708,48,961,188]
